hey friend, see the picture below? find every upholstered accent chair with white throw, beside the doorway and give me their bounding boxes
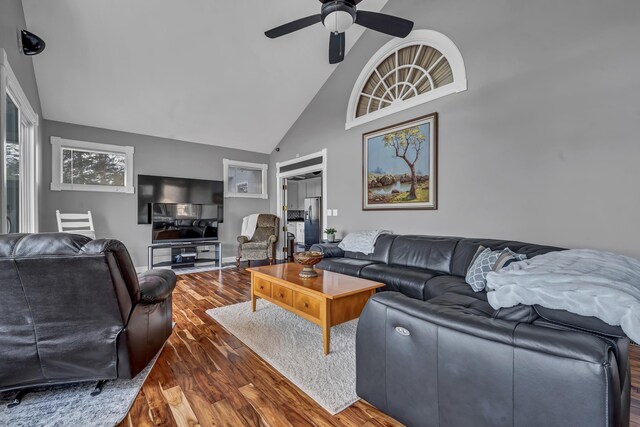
[236,214,280,267]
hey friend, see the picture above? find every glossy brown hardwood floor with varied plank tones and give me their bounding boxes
[120,268,640,427]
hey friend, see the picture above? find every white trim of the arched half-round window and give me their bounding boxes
[345,30,467,130]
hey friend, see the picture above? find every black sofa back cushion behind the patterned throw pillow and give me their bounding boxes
[450,239,564,276]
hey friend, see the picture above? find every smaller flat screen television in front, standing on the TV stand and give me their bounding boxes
[151,203,219,243]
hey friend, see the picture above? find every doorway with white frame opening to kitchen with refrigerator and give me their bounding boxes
[276,149,327,259]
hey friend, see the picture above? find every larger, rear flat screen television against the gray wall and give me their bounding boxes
[138,175,224,224]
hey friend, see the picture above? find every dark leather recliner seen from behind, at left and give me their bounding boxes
[0,233,176,391]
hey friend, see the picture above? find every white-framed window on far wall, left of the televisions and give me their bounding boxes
[51,136,134,193]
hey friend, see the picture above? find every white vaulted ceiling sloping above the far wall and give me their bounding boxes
[23,0,387,153]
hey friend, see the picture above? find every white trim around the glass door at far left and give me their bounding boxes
[0,49,40,233]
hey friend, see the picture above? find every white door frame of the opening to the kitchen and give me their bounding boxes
[276,148,328,259]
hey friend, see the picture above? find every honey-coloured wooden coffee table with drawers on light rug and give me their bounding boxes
[248,263,384,355]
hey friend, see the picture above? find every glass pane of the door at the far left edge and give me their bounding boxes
[4,96,23,233]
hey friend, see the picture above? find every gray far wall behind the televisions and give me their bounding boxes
[40,120,269,267]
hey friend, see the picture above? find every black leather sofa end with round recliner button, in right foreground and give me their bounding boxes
[356,292,629,427]
